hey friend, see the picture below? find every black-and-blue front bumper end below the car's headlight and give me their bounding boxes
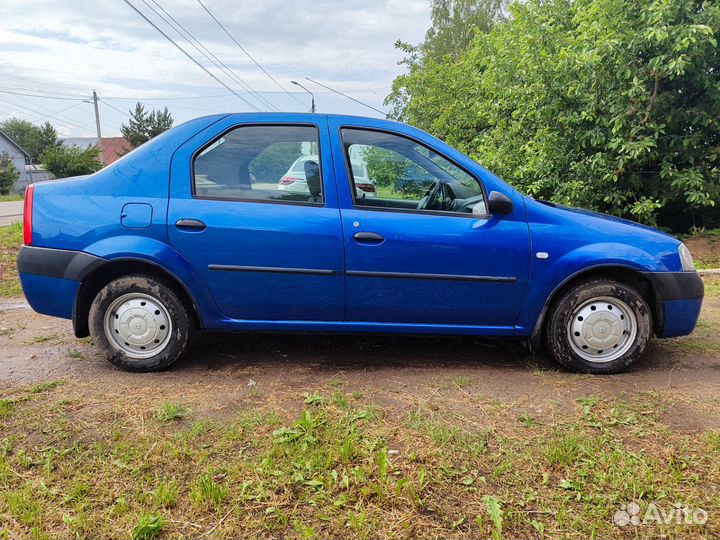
[643,272,705,338]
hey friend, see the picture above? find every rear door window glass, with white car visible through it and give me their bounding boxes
[193,126,324,204]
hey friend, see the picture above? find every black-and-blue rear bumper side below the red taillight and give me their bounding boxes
[17,246,105,319]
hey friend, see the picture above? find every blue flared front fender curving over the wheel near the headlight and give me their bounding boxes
[516,242,669,336]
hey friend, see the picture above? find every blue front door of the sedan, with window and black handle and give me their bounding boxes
[332,125,530,334]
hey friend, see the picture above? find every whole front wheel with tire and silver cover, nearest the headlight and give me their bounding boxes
[545,280,652,374]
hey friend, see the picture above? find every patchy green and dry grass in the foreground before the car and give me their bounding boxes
[0,381,720,539]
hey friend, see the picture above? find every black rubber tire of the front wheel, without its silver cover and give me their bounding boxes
[545,279,652,374]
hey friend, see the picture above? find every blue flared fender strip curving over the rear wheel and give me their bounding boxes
[84,235,221,321]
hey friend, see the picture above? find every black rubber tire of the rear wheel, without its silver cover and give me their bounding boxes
[88,275,195,372]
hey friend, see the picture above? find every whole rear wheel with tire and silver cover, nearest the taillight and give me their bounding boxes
[89,275,193,372]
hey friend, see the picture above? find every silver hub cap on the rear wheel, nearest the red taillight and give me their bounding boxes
[105,293,172,359]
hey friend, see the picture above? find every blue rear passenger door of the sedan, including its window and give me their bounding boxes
[168,115,345,320]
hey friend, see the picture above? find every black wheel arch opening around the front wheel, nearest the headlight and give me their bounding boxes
[530,265,663,352]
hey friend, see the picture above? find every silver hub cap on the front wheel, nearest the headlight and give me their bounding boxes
[568,296,637,363]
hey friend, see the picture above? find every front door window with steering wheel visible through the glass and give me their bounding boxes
[342,128,486,214]
